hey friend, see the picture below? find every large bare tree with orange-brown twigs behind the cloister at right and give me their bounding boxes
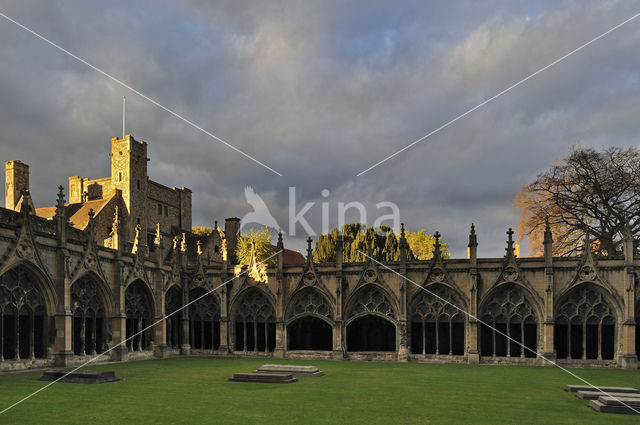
[514,146,640,255]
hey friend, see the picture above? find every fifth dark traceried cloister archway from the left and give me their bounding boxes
[189,288,220,350]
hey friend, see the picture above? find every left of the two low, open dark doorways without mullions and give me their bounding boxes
[287,316,333,351]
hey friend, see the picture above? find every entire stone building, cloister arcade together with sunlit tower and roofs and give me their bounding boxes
[0,135,640,371]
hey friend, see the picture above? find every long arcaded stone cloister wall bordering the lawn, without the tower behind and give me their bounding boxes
[0,209,640,370]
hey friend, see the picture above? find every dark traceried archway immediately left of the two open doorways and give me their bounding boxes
[232,288,276,353]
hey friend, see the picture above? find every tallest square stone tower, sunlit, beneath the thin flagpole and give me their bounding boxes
[109,134,149,241]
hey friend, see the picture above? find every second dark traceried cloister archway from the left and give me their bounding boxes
[71,276,107,355]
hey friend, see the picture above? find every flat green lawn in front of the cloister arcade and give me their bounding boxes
[0,358,640,424]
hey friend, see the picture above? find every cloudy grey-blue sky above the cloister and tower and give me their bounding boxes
[0,0,640,257]
